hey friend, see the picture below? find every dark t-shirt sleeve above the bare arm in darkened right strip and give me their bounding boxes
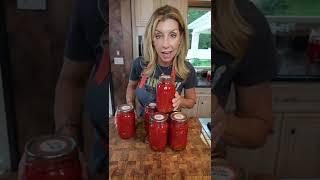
[234,1,277,86]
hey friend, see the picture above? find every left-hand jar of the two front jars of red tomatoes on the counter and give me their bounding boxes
[149,112,168,151]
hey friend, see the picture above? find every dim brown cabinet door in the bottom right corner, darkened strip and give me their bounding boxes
[278,113,320,178]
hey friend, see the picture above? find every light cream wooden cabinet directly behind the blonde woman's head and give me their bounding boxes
[131,0,188,58]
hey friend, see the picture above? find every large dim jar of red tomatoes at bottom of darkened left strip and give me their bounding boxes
[23,136,81,180]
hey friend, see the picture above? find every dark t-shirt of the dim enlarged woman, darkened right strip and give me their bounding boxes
[213,0,277,106]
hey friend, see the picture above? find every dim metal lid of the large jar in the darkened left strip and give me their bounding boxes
[25,135,76,159]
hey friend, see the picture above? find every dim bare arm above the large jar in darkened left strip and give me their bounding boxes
[54,58,93,141]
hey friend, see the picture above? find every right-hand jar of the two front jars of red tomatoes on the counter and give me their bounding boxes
[169,112,188,151]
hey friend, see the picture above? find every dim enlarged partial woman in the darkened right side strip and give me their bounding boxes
[212,0,276,178]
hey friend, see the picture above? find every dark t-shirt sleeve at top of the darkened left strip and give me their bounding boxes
[64,0,95,62]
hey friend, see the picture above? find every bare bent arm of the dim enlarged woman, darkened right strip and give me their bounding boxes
[219,83,274,148]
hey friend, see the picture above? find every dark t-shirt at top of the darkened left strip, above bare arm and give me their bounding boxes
[65,0,107,64]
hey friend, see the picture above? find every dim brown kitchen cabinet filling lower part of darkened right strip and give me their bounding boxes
[226,82,320,179]
